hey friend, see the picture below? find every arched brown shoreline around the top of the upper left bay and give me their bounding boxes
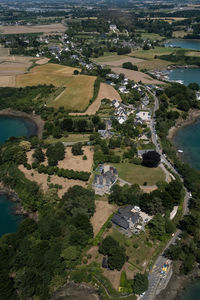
[0,108,45,139]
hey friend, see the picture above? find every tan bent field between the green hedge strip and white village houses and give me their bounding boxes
[70,83,122,116]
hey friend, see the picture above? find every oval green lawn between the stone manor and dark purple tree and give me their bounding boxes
[113,163,165,185]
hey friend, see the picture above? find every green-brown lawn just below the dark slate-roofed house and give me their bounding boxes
[111,228,155,272]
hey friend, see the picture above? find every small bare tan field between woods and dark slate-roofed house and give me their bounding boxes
[90,200,117,236]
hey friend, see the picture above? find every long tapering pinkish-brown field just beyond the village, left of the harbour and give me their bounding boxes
[112,68,163,84]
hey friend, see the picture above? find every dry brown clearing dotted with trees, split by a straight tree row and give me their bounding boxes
[19,147,93,197]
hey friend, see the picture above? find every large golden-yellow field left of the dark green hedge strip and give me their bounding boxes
[16,64,96,111]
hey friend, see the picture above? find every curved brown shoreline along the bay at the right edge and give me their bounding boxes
[167,109,200,142]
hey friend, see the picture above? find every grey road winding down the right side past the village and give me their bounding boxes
[141,89,190,300]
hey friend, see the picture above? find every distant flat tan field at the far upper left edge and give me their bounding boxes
[0,23,66,34]
